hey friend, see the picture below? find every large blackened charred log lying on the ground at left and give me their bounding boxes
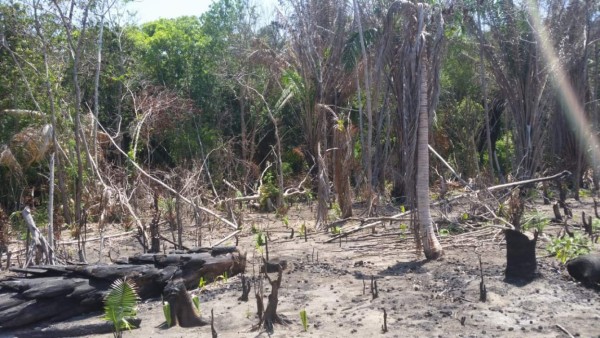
[0,251,245,330]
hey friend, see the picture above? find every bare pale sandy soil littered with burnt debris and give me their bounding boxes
[4,199,600,338]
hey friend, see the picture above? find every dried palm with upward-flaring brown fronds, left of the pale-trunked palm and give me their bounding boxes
[288,0,353,228]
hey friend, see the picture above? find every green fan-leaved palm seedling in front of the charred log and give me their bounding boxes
[104,279,140,338]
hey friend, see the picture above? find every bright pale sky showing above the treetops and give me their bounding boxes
[127,0,277,23]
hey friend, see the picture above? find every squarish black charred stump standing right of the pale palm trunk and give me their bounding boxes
[504,230,537,283]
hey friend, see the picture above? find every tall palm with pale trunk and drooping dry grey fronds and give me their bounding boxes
[382,1,444,259]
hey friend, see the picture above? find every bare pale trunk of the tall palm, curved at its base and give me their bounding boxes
[416,62,443,259]
